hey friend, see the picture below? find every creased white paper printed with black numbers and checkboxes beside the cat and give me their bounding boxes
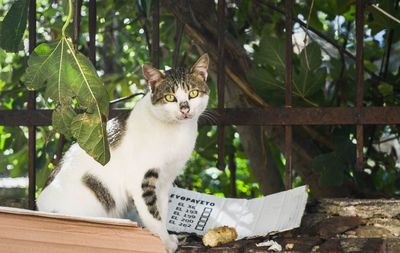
[167,186,308,239]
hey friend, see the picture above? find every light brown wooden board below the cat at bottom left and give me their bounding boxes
[0,207,165,253]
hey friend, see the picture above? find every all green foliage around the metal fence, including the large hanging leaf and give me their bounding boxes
[0,0,400,197]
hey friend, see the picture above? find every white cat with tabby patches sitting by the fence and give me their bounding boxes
[37,54,209,252]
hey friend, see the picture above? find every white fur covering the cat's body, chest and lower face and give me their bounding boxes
[37,89,208,252]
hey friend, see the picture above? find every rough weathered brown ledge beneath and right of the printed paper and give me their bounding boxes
[178,199,400,253]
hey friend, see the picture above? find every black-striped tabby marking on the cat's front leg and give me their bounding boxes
[142,169,161,220]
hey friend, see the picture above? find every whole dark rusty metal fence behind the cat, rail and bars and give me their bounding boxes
[0,0,400,209]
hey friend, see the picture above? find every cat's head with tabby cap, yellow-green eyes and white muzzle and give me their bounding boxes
[143,54,209,122]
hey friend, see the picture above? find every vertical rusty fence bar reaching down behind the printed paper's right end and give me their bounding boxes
[285,0,294,189]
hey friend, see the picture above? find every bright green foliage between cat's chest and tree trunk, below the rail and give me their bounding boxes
[177,127,261,198]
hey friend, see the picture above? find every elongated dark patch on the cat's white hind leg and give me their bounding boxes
[82,173,115,212]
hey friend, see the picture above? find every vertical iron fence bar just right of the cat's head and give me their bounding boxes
[217,0,225,170]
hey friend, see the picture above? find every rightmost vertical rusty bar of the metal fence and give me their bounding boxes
[356,0,364,171]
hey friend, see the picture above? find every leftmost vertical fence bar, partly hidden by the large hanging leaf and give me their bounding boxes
[28,0,36,210]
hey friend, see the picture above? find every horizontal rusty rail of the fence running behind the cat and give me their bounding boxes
[0,106,400,126]
